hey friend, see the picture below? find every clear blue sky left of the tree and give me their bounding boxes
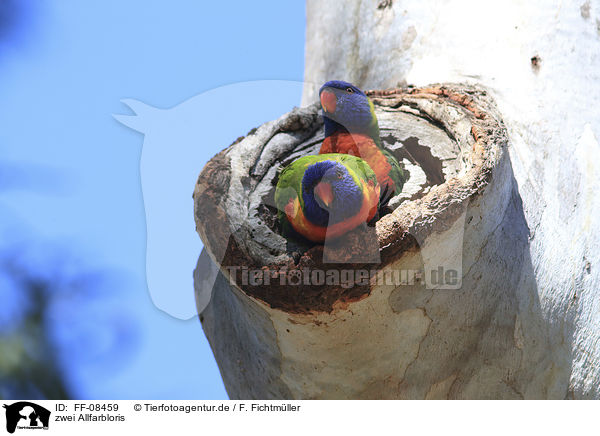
[0,0,305,399]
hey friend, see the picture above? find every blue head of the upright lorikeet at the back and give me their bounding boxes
[319,80,379,140]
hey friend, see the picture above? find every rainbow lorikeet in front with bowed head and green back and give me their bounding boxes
[275,154,380,243]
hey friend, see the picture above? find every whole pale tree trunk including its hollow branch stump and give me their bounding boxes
[195,0,600,398]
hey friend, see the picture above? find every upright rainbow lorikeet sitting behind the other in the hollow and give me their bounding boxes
[319,80,406,206]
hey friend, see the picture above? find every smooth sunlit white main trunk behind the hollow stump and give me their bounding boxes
[303,0,600,398]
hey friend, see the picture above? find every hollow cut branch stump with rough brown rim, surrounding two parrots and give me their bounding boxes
[194,85,556,398]
